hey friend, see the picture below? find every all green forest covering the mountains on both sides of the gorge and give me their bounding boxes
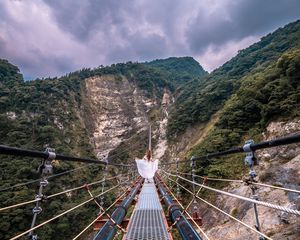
[0,21,300,239]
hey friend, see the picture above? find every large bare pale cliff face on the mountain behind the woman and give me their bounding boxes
[82,75,157,159]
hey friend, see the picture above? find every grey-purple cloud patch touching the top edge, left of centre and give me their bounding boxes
[44,0,138,41]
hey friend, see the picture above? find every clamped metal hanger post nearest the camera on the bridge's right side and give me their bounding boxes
[243,140,265,240]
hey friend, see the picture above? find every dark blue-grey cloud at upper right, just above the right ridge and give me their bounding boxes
[187,0,300,54]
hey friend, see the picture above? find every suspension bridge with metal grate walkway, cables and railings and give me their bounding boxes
[0,134,300,240]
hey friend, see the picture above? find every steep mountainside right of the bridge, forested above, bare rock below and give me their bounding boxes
[165,21,300,240]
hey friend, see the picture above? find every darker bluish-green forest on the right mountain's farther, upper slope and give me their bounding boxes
[168,21,300,137]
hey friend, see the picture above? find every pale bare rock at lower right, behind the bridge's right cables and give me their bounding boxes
[201,119,300,240]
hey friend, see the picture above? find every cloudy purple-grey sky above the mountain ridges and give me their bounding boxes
[0,0,300,79]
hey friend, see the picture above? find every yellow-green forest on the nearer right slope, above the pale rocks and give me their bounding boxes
[192,48,300,177]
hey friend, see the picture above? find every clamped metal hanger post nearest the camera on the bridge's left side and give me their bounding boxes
[29,148,56,240]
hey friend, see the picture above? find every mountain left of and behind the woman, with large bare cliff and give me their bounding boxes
[0,58,204,239]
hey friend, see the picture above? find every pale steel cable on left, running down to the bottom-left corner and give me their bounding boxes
[10,184,120,240]
